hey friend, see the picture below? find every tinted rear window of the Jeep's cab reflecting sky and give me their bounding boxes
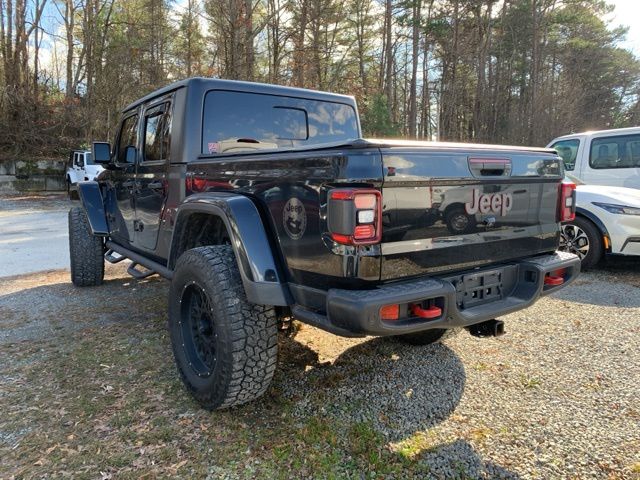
[202,90,359,155]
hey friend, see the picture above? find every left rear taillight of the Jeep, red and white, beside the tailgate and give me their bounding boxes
[327,188,382,245]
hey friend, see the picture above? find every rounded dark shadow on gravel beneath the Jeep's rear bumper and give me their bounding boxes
[279,338,466,441]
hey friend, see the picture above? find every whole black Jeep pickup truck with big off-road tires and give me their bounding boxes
[69,78,580,409]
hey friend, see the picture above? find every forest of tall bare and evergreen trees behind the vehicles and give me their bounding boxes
[0,0,640,159]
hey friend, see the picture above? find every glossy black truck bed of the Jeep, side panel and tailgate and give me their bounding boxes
[188,139,562,289]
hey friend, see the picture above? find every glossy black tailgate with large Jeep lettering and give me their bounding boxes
[381,145,563,281]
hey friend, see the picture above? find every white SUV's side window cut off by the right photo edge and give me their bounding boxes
[589,134,640,169]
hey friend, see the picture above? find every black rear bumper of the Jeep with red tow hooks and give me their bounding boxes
[293,252,580,336]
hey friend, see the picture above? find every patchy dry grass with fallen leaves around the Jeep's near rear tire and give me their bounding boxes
[0,269,420,478]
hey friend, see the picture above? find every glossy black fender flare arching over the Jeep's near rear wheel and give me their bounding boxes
[168,192,293,306]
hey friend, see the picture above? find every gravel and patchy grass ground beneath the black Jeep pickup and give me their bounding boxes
[0,261,640,479]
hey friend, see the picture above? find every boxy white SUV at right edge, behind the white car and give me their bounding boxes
[548,127,640,188]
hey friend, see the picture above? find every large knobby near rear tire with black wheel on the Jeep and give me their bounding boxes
[169,245,278,410]
